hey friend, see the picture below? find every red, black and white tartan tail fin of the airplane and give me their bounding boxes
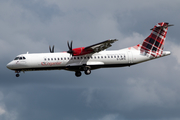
[140,22,172,57]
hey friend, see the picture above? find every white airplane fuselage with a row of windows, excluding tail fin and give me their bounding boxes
[7,48,170,71]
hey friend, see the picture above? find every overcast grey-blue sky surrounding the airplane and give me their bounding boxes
[0,0,180,120]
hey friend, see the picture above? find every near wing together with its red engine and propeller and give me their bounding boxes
[67,39,118,56]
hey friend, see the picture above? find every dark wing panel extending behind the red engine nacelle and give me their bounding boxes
[84,39,118,53]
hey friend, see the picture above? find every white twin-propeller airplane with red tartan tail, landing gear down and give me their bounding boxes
[7,22,173,77]
